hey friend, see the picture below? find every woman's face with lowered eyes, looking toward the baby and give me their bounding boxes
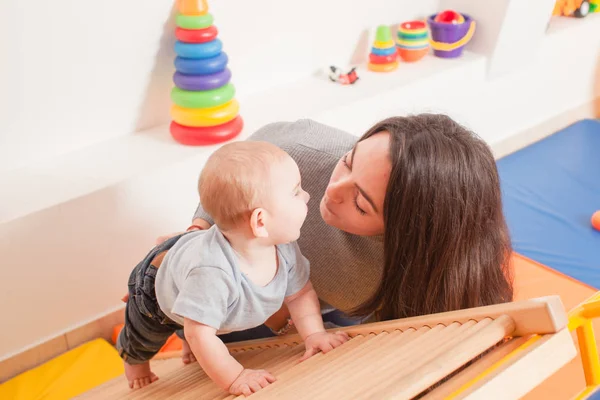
[320,131,392,236]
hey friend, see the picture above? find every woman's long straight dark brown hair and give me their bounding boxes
[353,114,513,320]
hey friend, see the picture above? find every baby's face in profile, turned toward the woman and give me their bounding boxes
[267,157,310,244]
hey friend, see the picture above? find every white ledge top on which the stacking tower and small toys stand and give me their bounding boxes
[0,52,485,223]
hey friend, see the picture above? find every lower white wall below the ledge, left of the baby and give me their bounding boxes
[0,154,202,360]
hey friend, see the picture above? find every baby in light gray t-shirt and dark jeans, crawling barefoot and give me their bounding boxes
[117,142,348,395]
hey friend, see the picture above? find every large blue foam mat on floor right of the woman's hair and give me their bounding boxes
[498,120,600,289]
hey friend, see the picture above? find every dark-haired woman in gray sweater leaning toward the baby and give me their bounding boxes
[171,114,512,341]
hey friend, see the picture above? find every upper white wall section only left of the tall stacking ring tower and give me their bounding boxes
[0,0,174,171]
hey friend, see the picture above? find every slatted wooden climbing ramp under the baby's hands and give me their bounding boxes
[77,296,576,400]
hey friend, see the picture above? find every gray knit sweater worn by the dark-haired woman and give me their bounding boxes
[194,120,383,311]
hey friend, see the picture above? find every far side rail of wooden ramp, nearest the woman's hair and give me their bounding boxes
[228,296,567,350]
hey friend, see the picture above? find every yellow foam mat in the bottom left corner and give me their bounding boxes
[0,339,123,400]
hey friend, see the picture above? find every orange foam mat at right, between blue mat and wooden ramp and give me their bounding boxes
[512,254,600,400]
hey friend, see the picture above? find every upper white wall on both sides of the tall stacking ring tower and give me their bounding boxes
[0,0,438,172]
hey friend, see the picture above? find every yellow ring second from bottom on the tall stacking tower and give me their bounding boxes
[171,99,240,127]
